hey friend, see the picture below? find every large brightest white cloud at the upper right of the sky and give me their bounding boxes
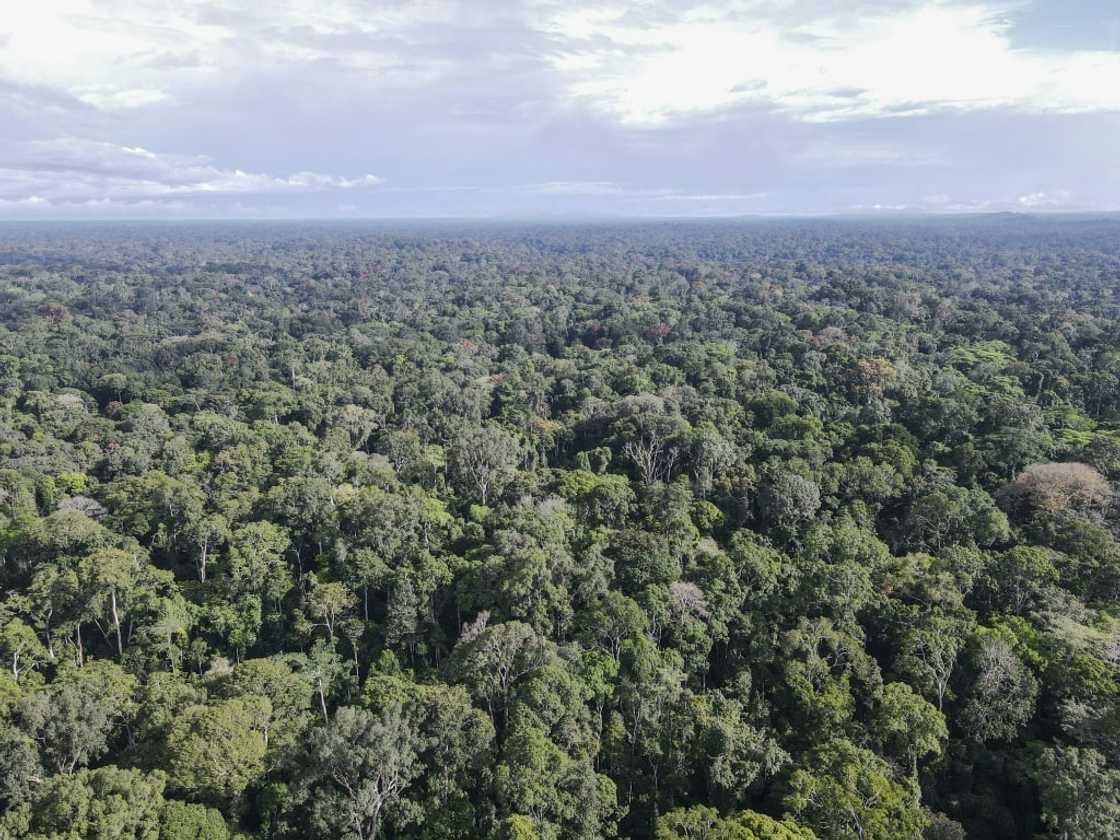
[533,0,1120,127]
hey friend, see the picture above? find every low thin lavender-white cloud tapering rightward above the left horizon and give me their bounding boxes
[0,137,381,203]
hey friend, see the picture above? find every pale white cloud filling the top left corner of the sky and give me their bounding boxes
[0,0,458,111]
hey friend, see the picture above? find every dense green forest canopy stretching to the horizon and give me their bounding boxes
[0,215,1120,840]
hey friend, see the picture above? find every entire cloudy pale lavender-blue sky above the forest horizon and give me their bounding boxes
[0,0,1120,220]
